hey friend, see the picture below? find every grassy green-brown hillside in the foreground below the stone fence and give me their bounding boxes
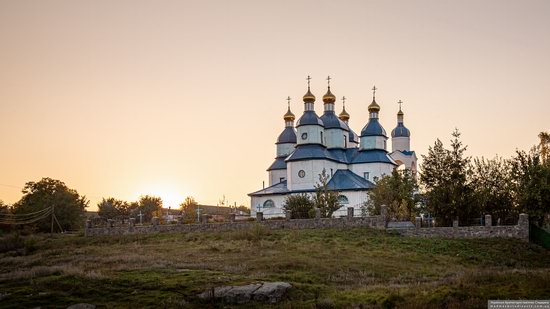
[0,226,550,308]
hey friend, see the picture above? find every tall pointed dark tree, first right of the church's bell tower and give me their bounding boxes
[420,129,480,224]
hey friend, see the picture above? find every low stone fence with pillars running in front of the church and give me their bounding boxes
[85,206,529,241]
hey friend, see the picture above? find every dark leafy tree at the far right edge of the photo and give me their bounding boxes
[511,148,550,226]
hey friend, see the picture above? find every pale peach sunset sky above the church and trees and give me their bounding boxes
[0,0,550,209]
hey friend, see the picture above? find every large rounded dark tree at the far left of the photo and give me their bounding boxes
[13,178,89,232]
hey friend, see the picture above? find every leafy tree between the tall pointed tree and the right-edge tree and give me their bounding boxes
[471,156,517,221]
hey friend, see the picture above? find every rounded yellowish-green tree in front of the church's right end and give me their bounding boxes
[363,169,420,221]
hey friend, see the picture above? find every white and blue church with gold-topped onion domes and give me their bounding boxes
[249,77,417,218]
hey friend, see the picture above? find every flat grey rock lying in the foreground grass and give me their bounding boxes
[199,282,292,304]
